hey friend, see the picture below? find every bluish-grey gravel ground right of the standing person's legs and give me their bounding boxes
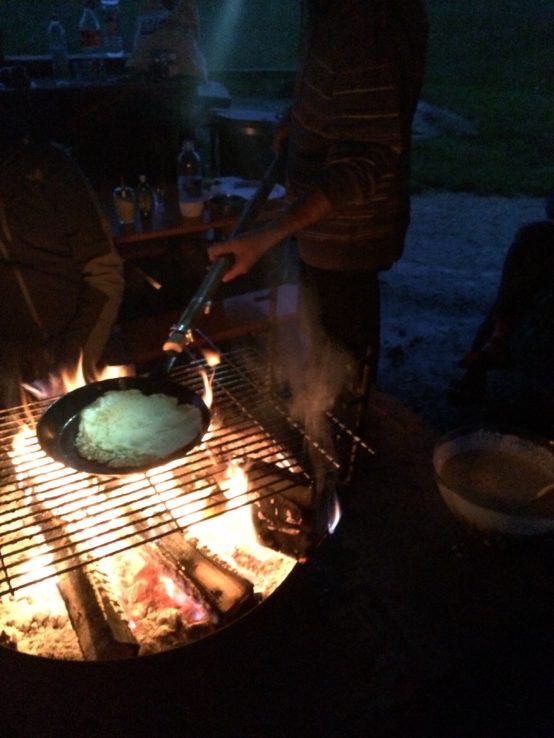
[378,192,552,432]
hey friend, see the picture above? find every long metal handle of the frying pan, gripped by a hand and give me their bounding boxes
[158,154,282,374]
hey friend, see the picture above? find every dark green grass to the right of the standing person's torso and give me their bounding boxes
[413,0,554,196]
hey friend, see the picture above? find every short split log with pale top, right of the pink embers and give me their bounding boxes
[154,533,256,620]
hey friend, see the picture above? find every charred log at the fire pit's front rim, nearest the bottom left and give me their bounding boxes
[58,565,139,661]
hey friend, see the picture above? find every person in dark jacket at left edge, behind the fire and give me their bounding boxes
[0,119,124,405]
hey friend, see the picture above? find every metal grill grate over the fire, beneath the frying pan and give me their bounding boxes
[0,348,369,595]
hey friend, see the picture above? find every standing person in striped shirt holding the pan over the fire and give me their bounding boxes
[210,0,427,428]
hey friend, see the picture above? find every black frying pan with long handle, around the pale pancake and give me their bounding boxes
[36,155,281,476]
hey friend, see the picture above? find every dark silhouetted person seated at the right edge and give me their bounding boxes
[450,193,554,400]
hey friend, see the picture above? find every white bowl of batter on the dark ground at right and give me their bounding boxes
[433,428,554,536]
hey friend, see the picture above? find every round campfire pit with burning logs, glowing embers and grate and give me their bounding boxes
[0,349,354,660]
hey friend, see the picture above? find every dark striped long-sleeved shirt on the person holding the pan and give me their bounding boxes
[288,0,426,269]
